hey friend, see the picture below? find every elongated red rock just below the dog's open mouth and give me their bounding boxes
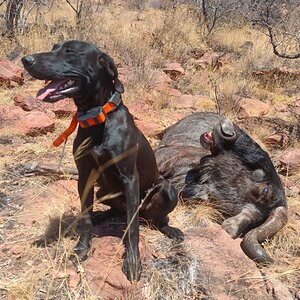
[14,94,77,117]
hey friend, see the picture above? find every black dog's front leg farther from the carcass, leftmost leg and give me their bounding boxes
[74,171,94,260]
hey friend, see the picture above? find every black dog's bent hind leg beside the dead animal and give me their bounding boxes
[142,176,184,241]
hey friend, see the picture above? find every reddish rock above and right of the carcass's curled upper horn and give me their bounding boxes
[237,98,270,118]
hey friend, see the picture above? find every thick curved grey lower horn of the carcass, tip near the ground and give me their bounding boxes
[241,206,287,264]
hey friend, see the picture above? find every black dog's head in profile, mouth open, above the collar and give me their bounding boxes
[22,40,124,111]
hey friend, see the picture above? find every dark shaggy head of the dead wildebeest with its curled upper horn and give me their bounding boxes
[182,119,286,215]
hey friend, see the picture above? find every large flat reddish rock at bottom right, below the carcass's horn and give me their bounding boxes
[185,225,292,300]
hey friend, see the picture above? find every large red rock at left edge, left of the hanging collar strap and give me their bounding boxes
[0,105,54,136]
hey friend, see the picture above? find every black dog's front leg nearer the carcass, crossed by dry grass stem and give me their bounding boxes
[121,166,141,281]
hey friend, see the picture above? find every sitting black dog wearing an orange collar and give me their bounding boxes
[22,40,183,280]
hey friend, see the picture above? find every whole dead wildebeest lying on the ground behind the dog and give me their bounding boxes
[156,112,287,263]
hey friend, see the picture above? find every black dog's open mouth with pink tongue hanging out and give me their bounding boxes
[37,79,80,102]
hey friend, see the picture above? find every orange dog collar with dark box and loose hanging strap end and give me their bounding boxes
[53,92,122,147]
